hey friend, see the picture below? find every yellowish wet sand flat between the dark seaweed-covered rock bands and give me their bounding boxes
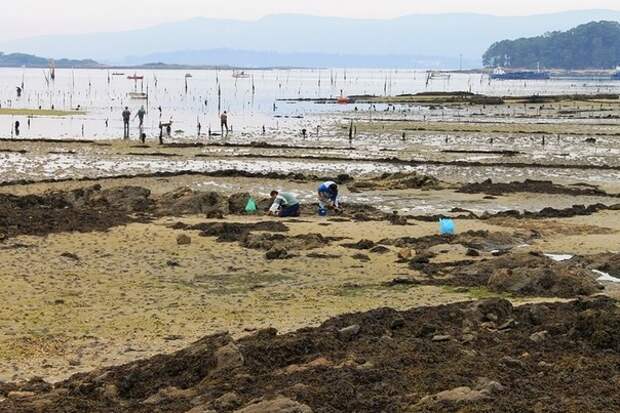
[0,204,620,380]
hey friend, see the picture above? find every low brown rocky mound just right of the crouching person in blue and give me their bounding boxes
[347,172,446,192]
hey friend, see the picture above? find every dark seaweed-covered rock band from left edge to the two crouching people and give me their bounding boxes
[0,183,386,239]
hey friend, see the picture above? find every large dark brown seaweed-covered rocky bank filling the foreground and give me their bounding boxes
[0,297,620,413]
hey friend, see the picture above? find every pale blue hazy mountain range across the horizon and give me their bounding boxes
[0,10,620,68]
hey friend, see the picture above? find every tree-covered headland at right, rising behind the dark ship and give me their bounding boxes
[483,21,620,70]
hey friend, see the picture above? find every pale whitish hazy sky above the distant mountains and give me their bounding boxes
[0,0,620,40]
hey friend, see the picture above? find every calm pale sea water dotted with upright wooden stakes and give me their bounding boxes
[0,69,620,140]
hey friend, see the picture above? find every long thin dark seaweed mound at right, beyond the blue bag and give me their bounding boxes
[457,179,616,196]
